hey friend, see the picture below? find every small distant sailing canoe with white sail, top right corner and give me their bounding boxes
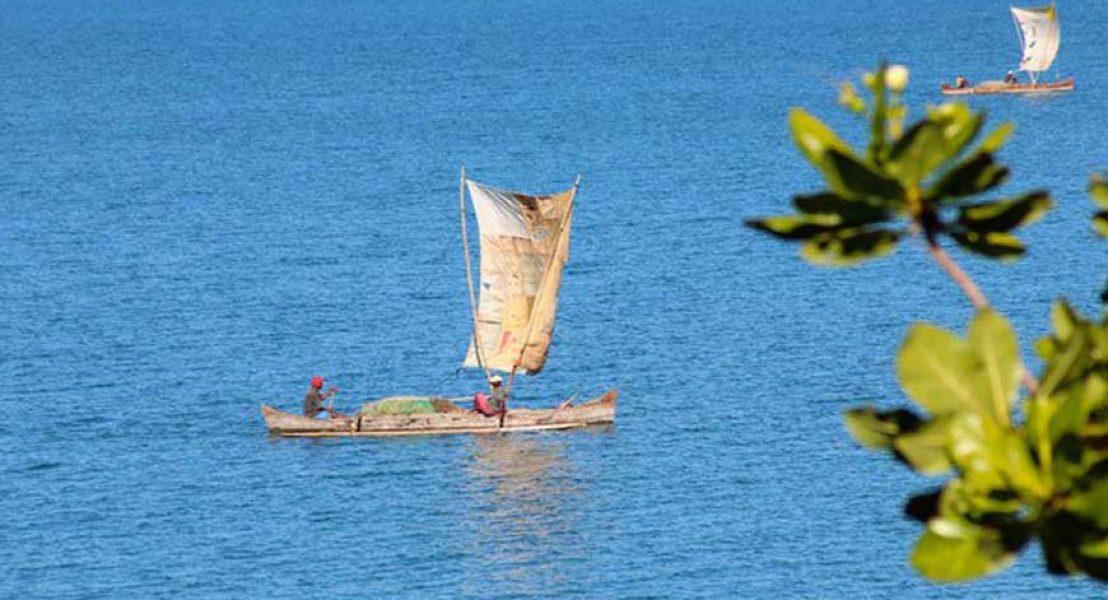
[940,3,1074,95]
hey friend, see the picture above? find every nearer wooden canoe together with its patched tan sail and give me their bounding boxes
[261,168,617,437]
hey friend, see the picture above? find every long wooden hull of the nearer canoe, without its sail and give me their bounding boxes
[261,389,617,437]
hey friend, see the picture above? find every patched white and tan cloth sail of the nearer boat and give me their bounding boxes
[465,179,576,374]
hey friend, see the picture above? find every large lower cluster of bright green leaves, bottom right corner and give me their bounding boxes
[845,302,1108,581]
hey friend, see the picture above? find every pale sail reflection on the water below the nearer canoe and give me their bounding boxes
[458,435,587,594]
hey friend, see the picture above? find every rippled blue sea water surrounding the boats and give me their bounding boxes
[0,0,1108,599]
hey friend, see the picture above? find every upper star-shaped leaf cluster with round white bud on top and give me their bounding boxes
[747,65,1053,266]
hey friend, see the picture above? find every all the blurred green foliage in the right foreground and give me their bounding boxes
[747,66,1108,581]
